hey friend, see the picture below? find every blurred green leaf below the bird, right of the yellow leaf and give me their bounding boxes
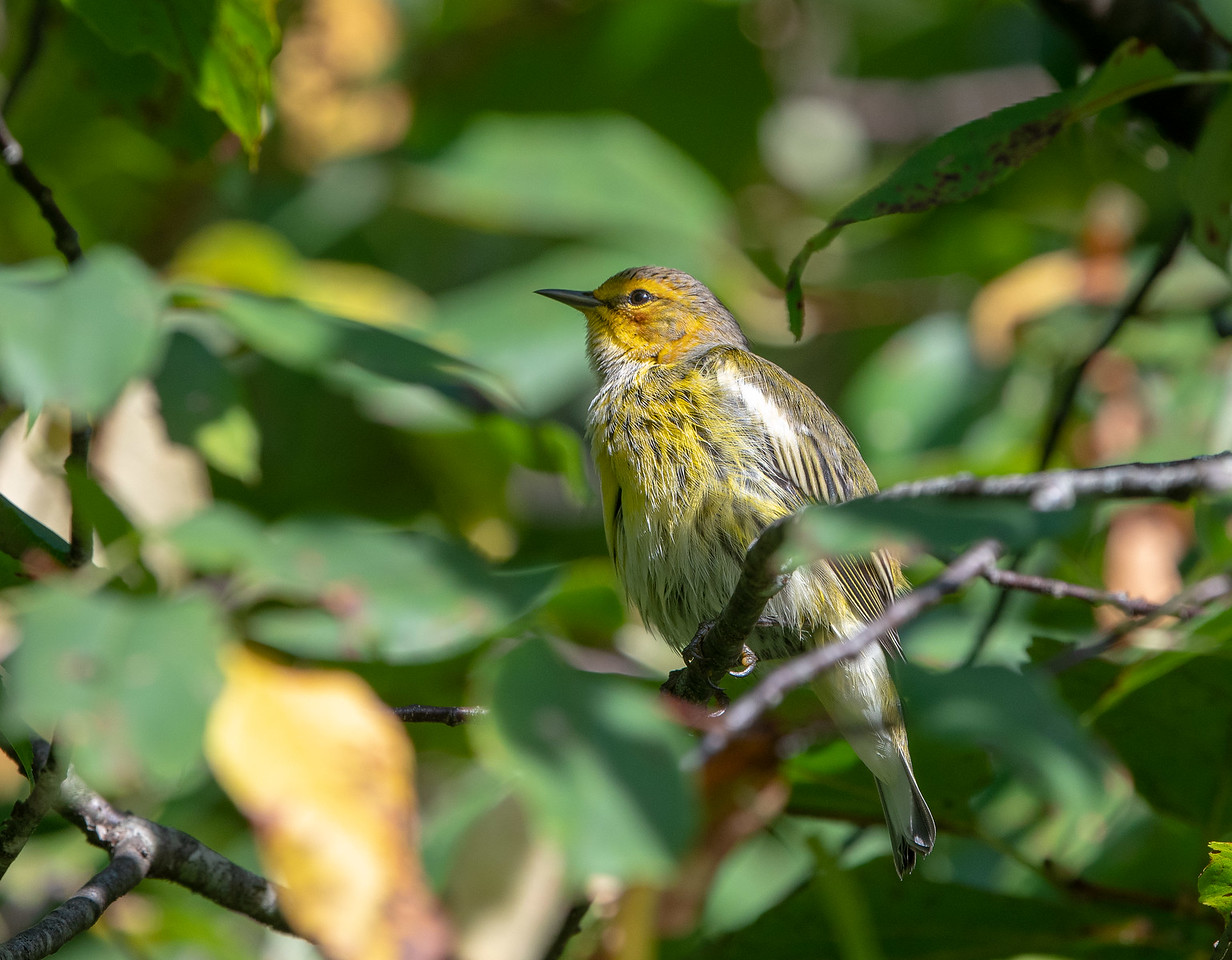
[474,640,695,881]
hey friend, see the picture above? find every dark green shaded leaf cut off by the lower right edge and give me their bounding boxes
[1092,653,1232,837]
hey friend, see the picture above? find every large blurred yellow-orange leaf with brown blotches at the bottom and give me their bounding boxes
[206,649,450,960]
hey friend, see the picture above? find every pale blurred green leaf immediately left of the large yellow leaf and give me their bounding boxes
[5,584,225,791]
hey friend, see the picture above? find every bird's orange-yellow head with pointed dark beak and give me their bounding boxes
[535,266,748,380]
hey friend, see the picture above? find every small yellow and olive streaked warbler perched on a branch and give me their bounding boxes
[536,266,936,877]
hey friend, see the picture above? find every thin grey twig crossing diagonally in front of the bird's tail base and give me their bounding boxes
[689,540,1002,765]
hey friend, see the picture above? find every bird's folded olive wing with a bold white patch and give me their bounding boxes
[712,349,906,657]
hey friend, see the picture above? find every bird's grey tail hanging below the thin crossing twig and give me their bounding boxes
[813,645,936,877]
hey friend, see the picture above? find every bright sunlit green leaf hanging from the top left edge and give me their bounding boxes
[62,0,280,154]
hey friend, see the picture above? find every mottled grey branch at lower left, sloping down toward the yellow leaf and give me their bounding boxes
[57,770,291,931]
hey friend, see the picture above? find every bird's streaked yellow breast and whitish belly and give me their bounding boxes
[590,354,802,646]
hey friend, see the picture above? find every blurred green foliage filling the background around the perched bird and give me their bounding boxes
[0,0,1232,960]
